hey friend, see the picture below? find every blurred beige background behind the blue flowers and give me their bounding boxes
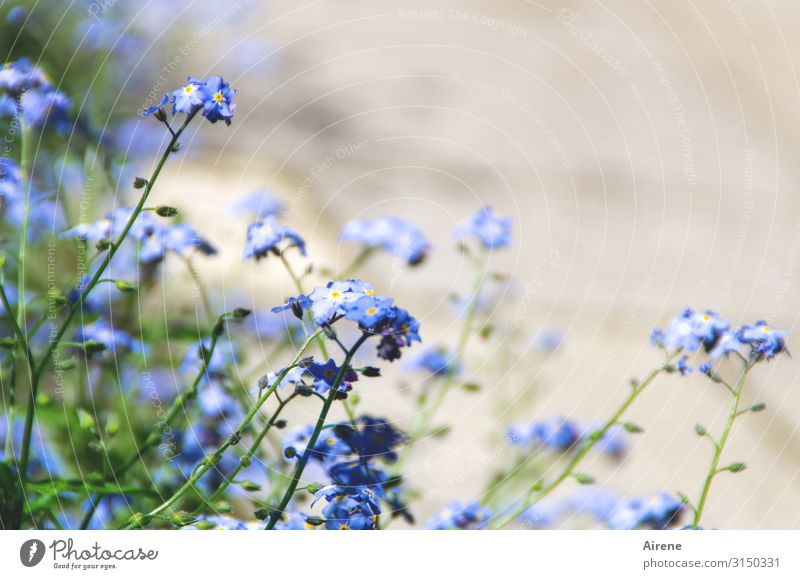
[145,0,800,528]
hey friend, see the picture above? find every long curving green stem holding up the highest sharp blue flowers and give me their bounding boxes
[20,109,199,483]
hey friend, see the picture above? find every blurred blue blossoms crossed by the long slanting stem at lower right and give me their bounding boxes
[507,416,627,457]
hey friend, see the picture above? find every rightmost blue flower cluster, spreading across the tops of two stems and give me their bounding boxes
[650,308,788,375]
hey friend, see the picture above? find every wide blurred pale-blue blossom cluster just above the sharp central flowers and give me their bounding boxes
[342,217,430,265]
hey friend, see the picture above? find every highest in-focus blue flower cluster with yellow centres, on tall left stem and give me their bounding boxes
[143,76,236,125]
